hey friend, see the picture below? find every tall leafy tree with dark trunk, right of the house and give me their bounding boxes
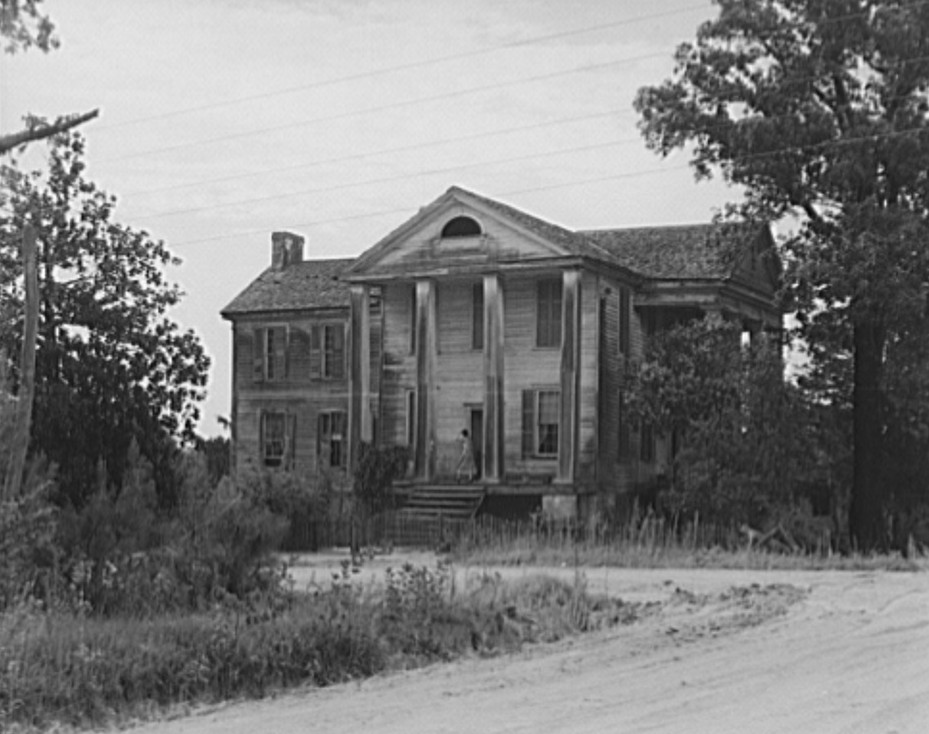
[635,0,929,549]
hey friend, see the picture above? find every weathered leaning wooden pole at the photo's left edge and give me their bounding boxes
[0,224,39,501]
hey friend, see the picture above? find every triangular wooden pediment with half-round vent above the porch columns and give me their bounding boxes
[344,187,577,279]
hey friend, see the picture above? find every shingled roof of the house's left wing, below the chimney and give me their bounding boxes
[222,258,354,317]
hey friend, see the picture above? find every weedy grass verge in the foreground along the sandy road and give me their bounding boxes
[0,564,637,731]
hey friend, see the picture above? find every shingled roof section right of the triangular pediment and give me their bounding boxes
[579,222,764,280]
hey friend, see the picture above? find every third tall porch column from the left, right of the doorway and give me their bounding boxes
[482,274,504,483]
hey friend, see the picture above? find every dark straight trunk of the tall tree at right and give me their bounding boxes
[848,322,887,552]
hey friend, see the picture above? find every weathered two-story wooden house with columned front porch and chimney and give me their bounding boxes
[223,187,781,515]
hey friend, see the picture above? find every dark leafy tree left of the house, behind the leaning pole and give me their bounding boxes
[0,133,209,507]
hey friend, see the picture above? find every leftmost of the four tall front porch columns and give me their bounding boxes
[348,285,371,468]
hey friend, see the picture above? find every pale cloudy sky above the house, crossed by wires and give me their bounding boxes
[0,0,738,436]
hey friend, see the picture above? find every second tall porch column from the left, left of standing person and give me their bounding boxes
[414,280,436,481]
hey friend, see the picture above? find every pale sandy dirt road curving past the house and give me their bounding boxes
[133,554,929,734]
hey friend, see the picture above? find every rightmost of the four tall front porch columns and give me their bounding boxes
[556,270,581,483]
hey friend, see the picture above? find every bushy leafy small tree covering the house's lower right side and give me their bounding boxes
[628,319,820,527]
